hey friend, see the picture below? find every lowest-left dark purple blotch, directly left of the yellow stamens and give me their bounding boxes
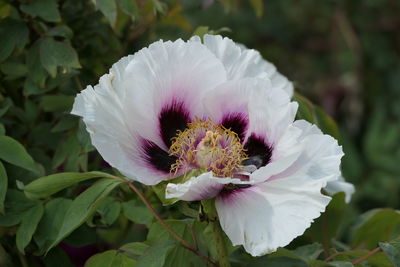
[142,140,177,173]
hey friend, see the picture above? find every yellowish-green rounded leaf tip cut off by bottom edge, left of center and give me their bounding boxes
[85,250,137,267]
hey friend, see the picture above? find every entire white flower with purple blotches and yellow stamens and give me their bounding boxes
[72,35,350,256]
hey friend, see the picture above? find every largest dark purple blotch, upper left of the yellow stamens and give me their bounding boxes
[158,99,190,147]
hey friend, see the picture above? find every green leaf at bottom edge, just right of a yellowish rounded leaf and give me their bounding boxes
[136,240,176,267]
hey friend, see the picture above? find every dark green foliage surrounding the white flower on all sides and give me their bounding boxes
[0,0,400,267]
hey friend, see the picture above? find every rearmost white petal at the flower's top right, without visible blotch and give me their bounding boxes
[191,34,293,97]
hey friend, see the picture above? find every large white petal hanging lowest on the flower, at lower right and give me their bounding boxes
[215,176,331,256]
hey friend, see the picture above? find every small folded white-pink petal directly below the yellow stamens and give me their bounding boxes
[165,172,253,201]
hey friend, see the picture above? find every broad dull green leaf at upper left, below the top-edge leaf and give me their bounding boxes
[40,38,81,77]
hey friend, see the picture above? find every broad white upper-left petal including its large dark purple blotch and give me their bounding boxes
[124,40,226,148]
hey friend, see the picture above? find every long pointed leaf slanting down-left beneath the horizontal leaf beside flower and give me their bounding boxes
[48,179,122,250]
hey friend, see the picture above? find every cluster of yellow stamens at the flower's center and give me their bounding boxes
[169,118,246,177]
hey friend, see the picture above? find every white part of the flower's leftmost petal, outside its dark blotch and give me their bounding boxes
[71,75,167,185]
